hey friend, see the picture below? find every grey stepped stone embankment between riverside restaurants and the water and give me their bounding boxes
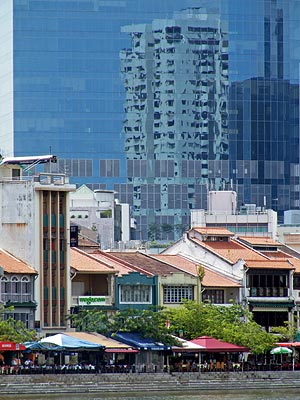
[0,371,300,396]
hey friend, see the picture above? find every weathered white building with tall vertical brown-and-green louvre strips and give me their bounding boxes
[0,164,75,332]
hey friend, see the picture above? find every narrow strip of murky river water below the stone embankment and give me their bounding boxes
[0,388,300,400]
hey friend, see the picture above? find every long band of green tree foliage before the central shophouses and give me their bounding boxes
[69,301,280,354]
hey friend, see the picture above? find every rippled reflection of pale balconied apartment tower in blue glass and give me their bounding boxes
[121,8,228,239]
